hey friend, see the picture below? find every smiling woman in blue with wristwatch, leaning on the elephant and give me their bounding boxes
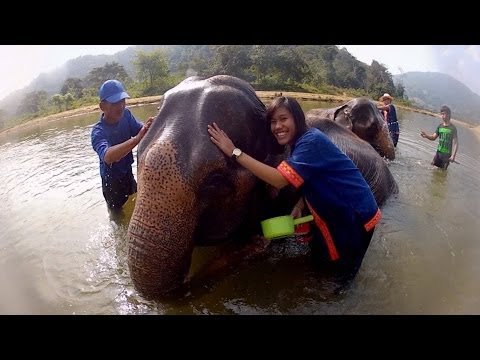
[208,96,381,279]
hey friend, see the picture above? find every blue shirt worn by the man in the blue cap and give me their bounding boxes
[91,109,143,179]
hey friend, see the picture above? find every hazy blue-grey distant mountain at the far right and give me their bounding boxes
[393,71,480,125]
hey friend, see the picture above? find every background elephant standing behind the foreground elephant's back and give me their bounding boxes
[305,97,395,160]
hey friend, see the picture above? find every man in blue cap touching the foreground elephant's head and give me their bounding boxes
[91,80,153,209]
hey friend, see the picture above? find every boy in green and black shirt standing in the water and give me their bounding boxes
[420,105,458,170]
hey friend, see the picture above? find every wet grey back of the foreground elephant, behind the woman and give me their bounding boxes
[308,114,398,206]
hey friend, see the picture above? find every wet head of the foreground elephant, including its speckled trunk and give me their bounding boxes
[128,76,283,297]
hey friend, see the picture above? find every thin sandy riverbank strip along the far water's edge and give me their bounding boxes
[0,91,480,139]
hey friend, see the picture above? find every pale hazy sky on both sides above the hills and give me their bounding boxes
[0,45,480,99]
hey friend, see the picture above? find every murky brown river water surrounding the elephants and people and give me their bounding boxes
[0,102,480,314]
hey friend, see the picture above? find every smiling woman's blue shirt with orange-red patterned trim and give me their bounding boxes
[277,128,381,260]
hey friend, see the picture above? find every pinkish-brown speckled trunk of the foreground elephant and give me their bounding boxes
[128,145,197,298]
